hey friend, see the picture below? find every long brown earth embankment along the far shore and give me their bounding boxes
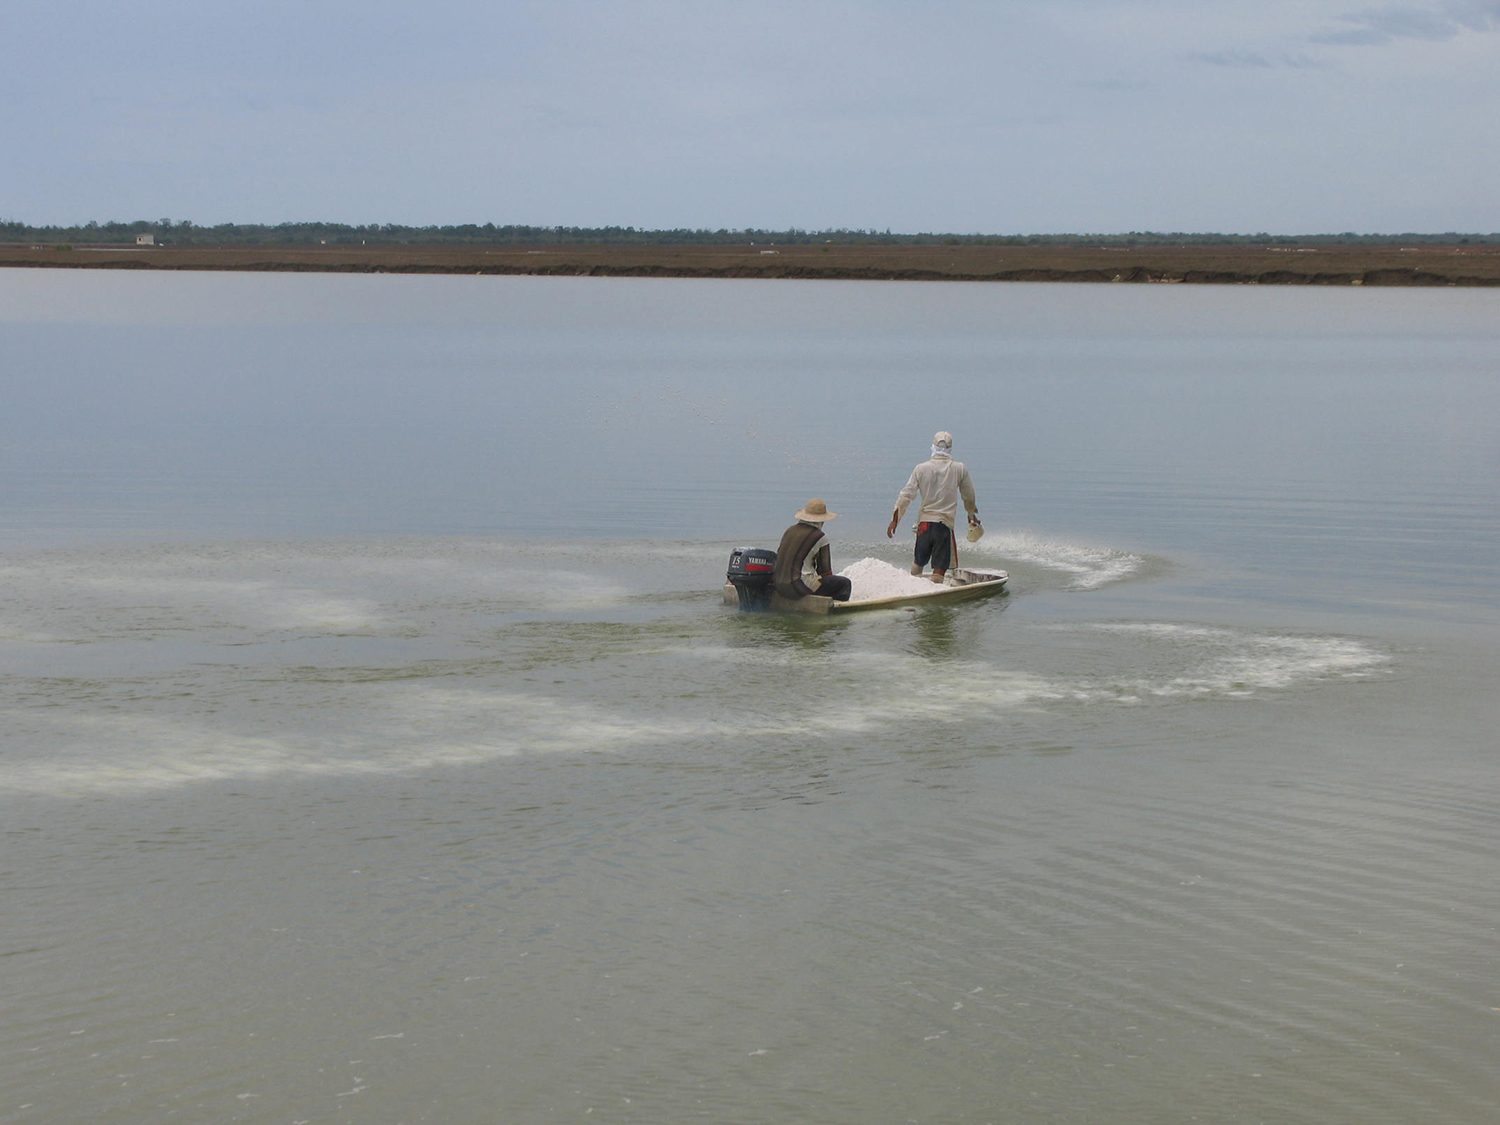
[0,245,1500,287]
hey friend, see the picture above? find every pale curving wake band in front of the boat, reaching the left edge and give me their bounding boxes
[0,618,1389,795]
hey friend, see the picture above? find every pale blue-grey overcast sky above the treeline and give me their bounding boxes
[0,0,1500,234]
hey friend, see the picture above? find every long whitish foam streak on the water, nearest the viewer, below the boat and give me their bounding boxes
[0,623,1389,795]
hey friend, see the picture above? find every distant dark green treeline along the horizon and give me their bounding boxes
[0,219,1500,246]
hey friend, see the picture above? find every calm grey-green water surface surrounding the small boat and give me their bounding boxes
[0,270,1500,1125]
